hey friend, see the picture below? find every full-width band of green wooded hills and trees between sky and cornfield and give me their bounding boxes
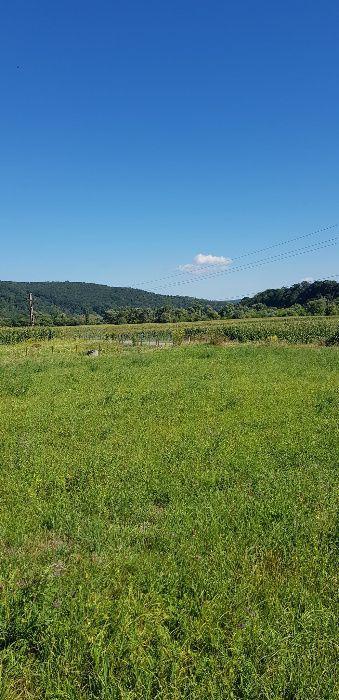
[0,280,339,326]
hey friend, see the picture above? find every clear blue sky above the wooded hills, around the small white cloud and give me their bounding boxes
[0,0,339,298]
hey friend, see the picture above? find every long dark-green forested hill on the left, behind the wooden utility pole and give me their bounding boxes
[0,282,223,318]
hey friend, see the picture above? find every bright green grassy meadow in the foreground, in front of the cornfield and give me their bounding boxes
[0,345,339,700]
